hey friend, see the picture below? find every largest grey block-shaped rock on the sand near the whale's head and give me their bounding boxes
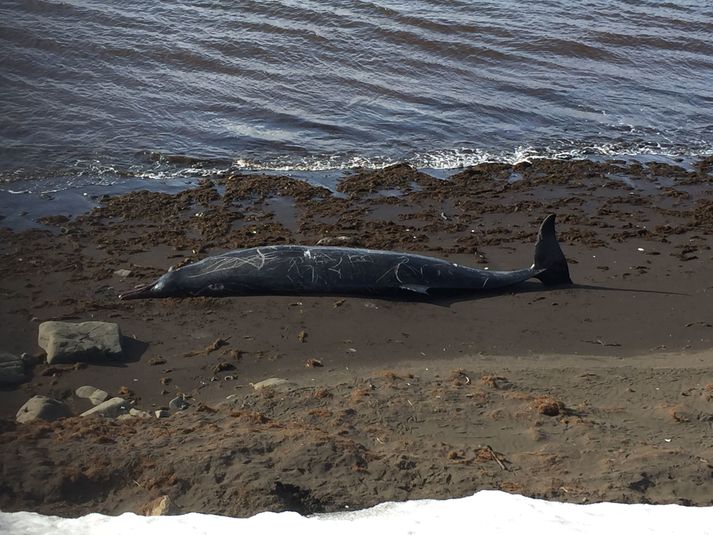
[37,321,123,364]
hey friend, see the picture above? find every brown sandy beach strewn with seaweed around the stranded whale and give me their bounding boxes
[0,158,713,516]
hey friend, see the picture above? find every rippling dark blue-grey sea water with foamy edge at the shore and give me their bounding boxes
[0,0,713,182]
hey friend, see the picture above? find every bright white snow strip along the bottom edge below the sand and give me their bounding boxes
[0,491,713,535]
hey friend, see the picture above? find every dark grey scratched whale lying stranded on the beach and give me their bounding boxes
[119,214,571,299]
